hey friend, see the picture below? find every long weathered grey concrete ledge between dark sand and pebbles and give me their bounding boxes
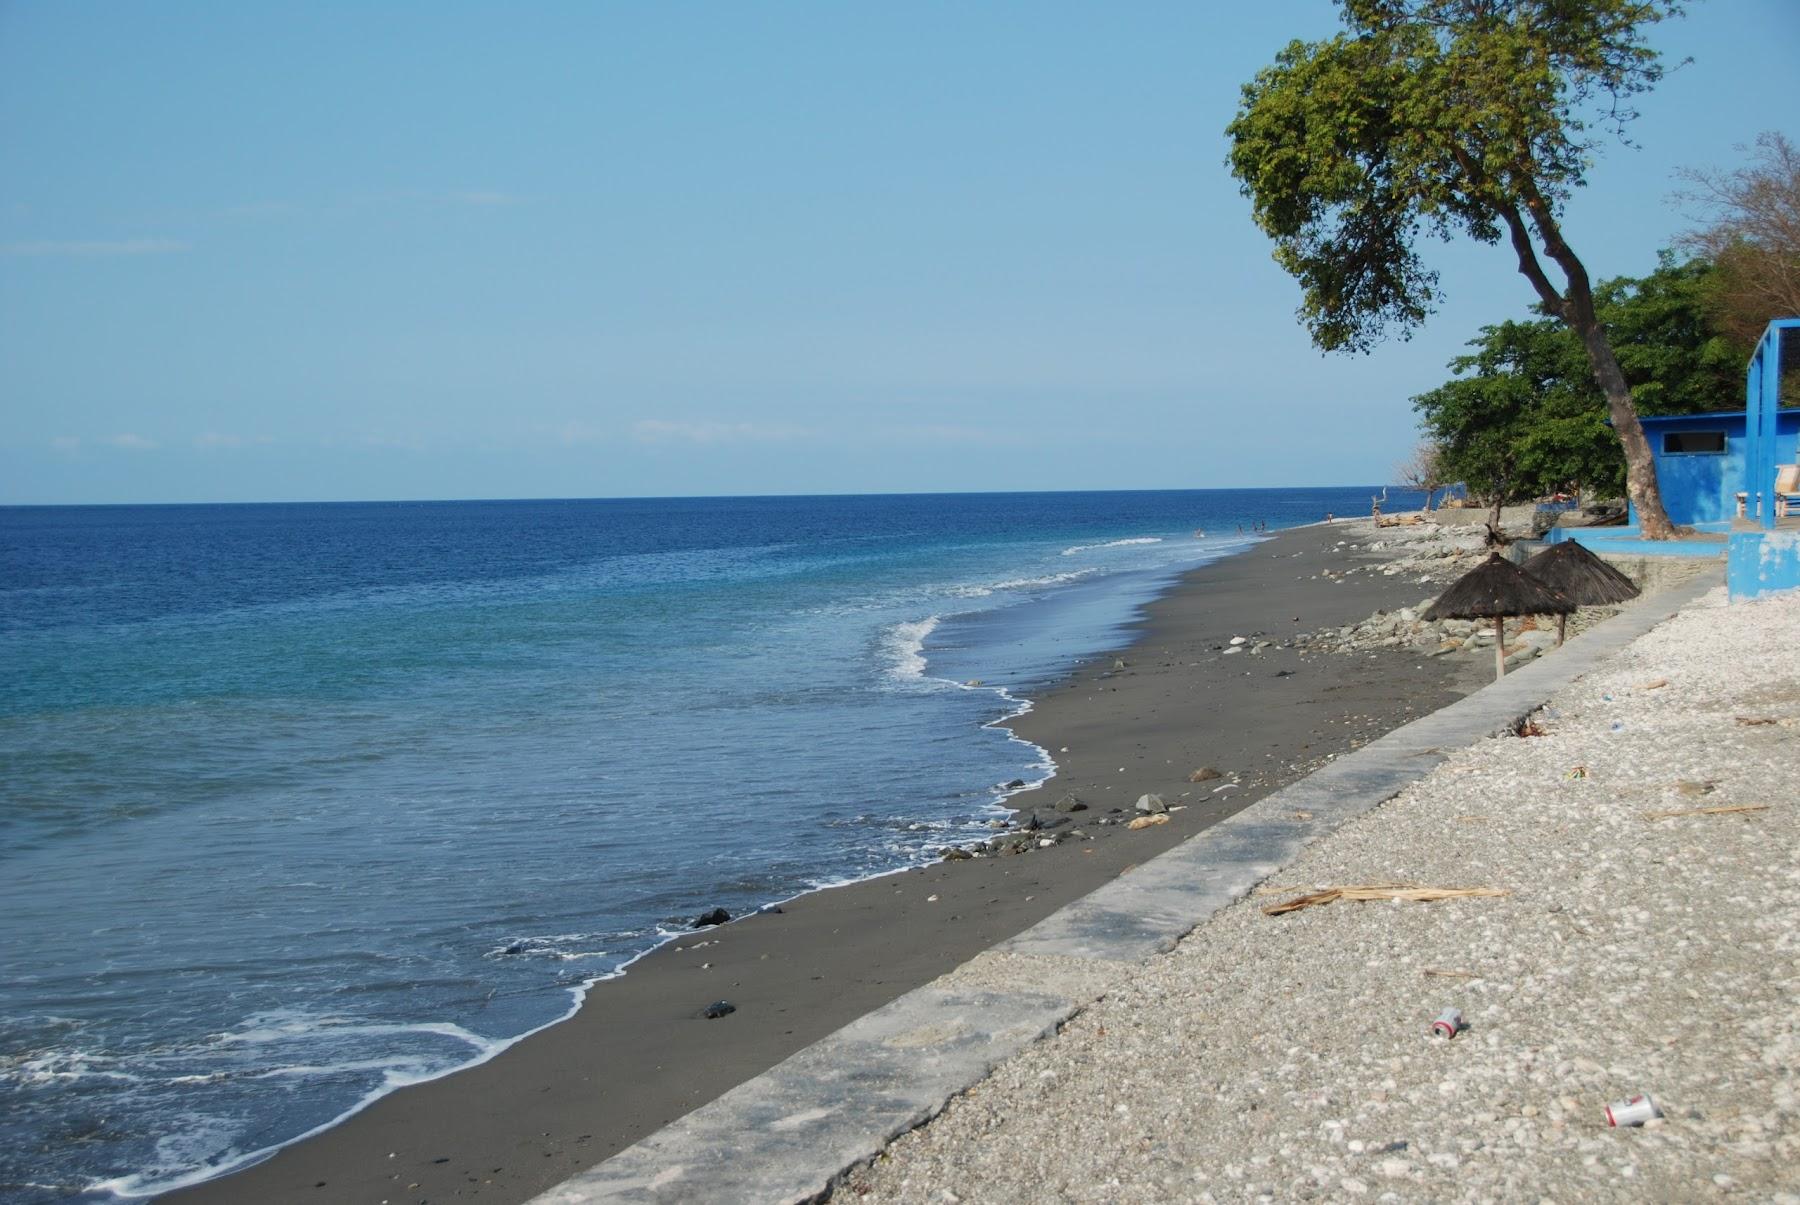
[536,575,1719,1205]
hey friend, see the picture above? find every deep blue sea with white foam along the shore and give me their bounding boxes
[0,488,1404,1200]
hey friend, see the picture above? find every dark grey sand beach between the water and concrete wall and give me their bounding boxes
[164,524,1492,1205]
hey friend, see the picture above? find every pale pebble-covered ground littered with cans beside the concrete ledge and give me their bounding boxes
[835,591,1800,1205]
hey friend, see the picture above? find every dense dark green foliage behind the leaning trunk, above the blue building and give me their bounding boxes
[1413,256,1750,503]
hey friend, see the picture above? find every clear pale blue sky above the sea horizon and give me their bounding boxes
[0,0,1800,503]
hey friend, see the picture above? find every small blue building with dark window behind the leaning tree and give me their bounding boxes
[1631,411,1800,526]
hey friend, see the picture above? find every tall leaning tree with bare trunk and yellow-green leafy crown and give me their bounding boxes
[1228,0,1679,539]
